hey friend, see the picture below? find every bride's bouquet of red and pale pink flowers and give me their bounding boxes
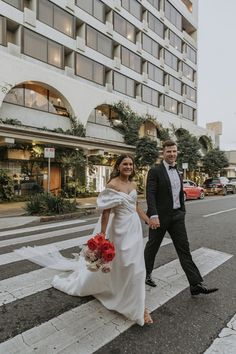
[83,234,115,273]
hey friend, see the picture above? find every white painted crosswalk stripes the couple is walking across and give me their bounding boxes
[0,218,232,354]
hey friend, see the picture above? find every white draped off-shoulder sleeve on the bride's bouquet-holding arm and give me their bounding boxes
[97,188,123,210]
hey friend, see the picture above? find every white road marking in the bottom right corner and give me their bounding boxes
[204,314,236,354]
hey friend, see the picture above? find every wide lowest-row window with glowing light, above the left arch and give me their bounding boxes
[23,28,64,68]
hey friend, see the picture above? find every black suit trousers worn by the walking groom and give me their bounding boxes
[144,209,203,285]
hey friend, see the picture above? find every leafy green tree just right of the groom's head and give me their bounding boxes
[177,131,201,171]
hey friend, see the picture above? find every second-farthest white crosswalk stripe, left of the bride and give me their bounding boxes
[0,224,97,248]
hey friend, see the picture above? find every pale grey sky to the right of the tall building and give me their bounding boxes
[198,0,236,150]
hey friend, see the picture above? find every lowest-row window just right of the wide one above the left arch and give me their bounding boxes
[76,54,105,85]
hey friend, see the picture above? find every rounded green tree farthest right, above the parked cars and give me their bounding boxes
[202,148,229,177]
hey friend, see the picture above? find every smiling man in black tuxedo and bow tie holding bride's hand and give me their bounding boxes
[144,140,218,295]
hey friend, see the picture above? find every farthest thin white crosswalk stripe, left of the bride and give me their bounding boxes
[0,218,98,237]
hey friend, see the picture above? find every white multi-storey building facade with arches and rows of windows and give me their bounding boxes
[0,0,215,191]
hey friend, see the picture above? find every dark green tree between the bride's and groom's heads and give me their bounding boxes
[134,137,159,169]
